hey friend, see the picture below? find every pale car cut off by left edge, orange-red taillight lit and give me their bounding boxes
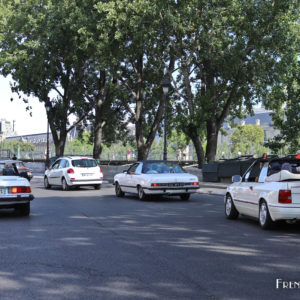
[0,160,34,216]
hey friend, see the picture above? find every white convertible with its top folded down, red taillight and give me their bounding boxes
[224,157,300,229]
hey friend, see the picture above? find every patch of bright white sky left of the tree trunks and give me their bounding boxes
[0,76,47,135]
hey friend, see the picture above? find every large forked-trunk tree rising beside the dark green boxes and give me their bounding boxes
[162,0,297,167]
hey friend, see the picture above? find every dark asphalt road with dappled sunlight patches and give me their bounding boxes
[0,182,300,300]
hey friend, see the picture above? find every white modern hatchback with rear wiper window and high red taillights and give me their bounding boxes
[44,156,103,191]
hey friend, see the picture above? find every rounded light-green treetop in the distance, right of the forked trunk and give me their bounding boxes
[231,125,264,154]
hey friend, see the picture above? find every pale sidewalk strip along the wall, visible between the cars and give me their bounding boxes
[32,173,229,196]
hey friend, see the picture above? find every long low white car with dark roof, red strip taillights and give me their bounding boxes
[114,161,199,200]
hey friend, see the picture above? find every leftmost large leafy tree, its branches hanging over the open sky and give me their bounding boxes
[0,0,86,155]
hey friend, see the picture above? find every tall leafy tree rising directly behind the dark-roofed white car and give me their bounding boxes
[96,0,174,160]
